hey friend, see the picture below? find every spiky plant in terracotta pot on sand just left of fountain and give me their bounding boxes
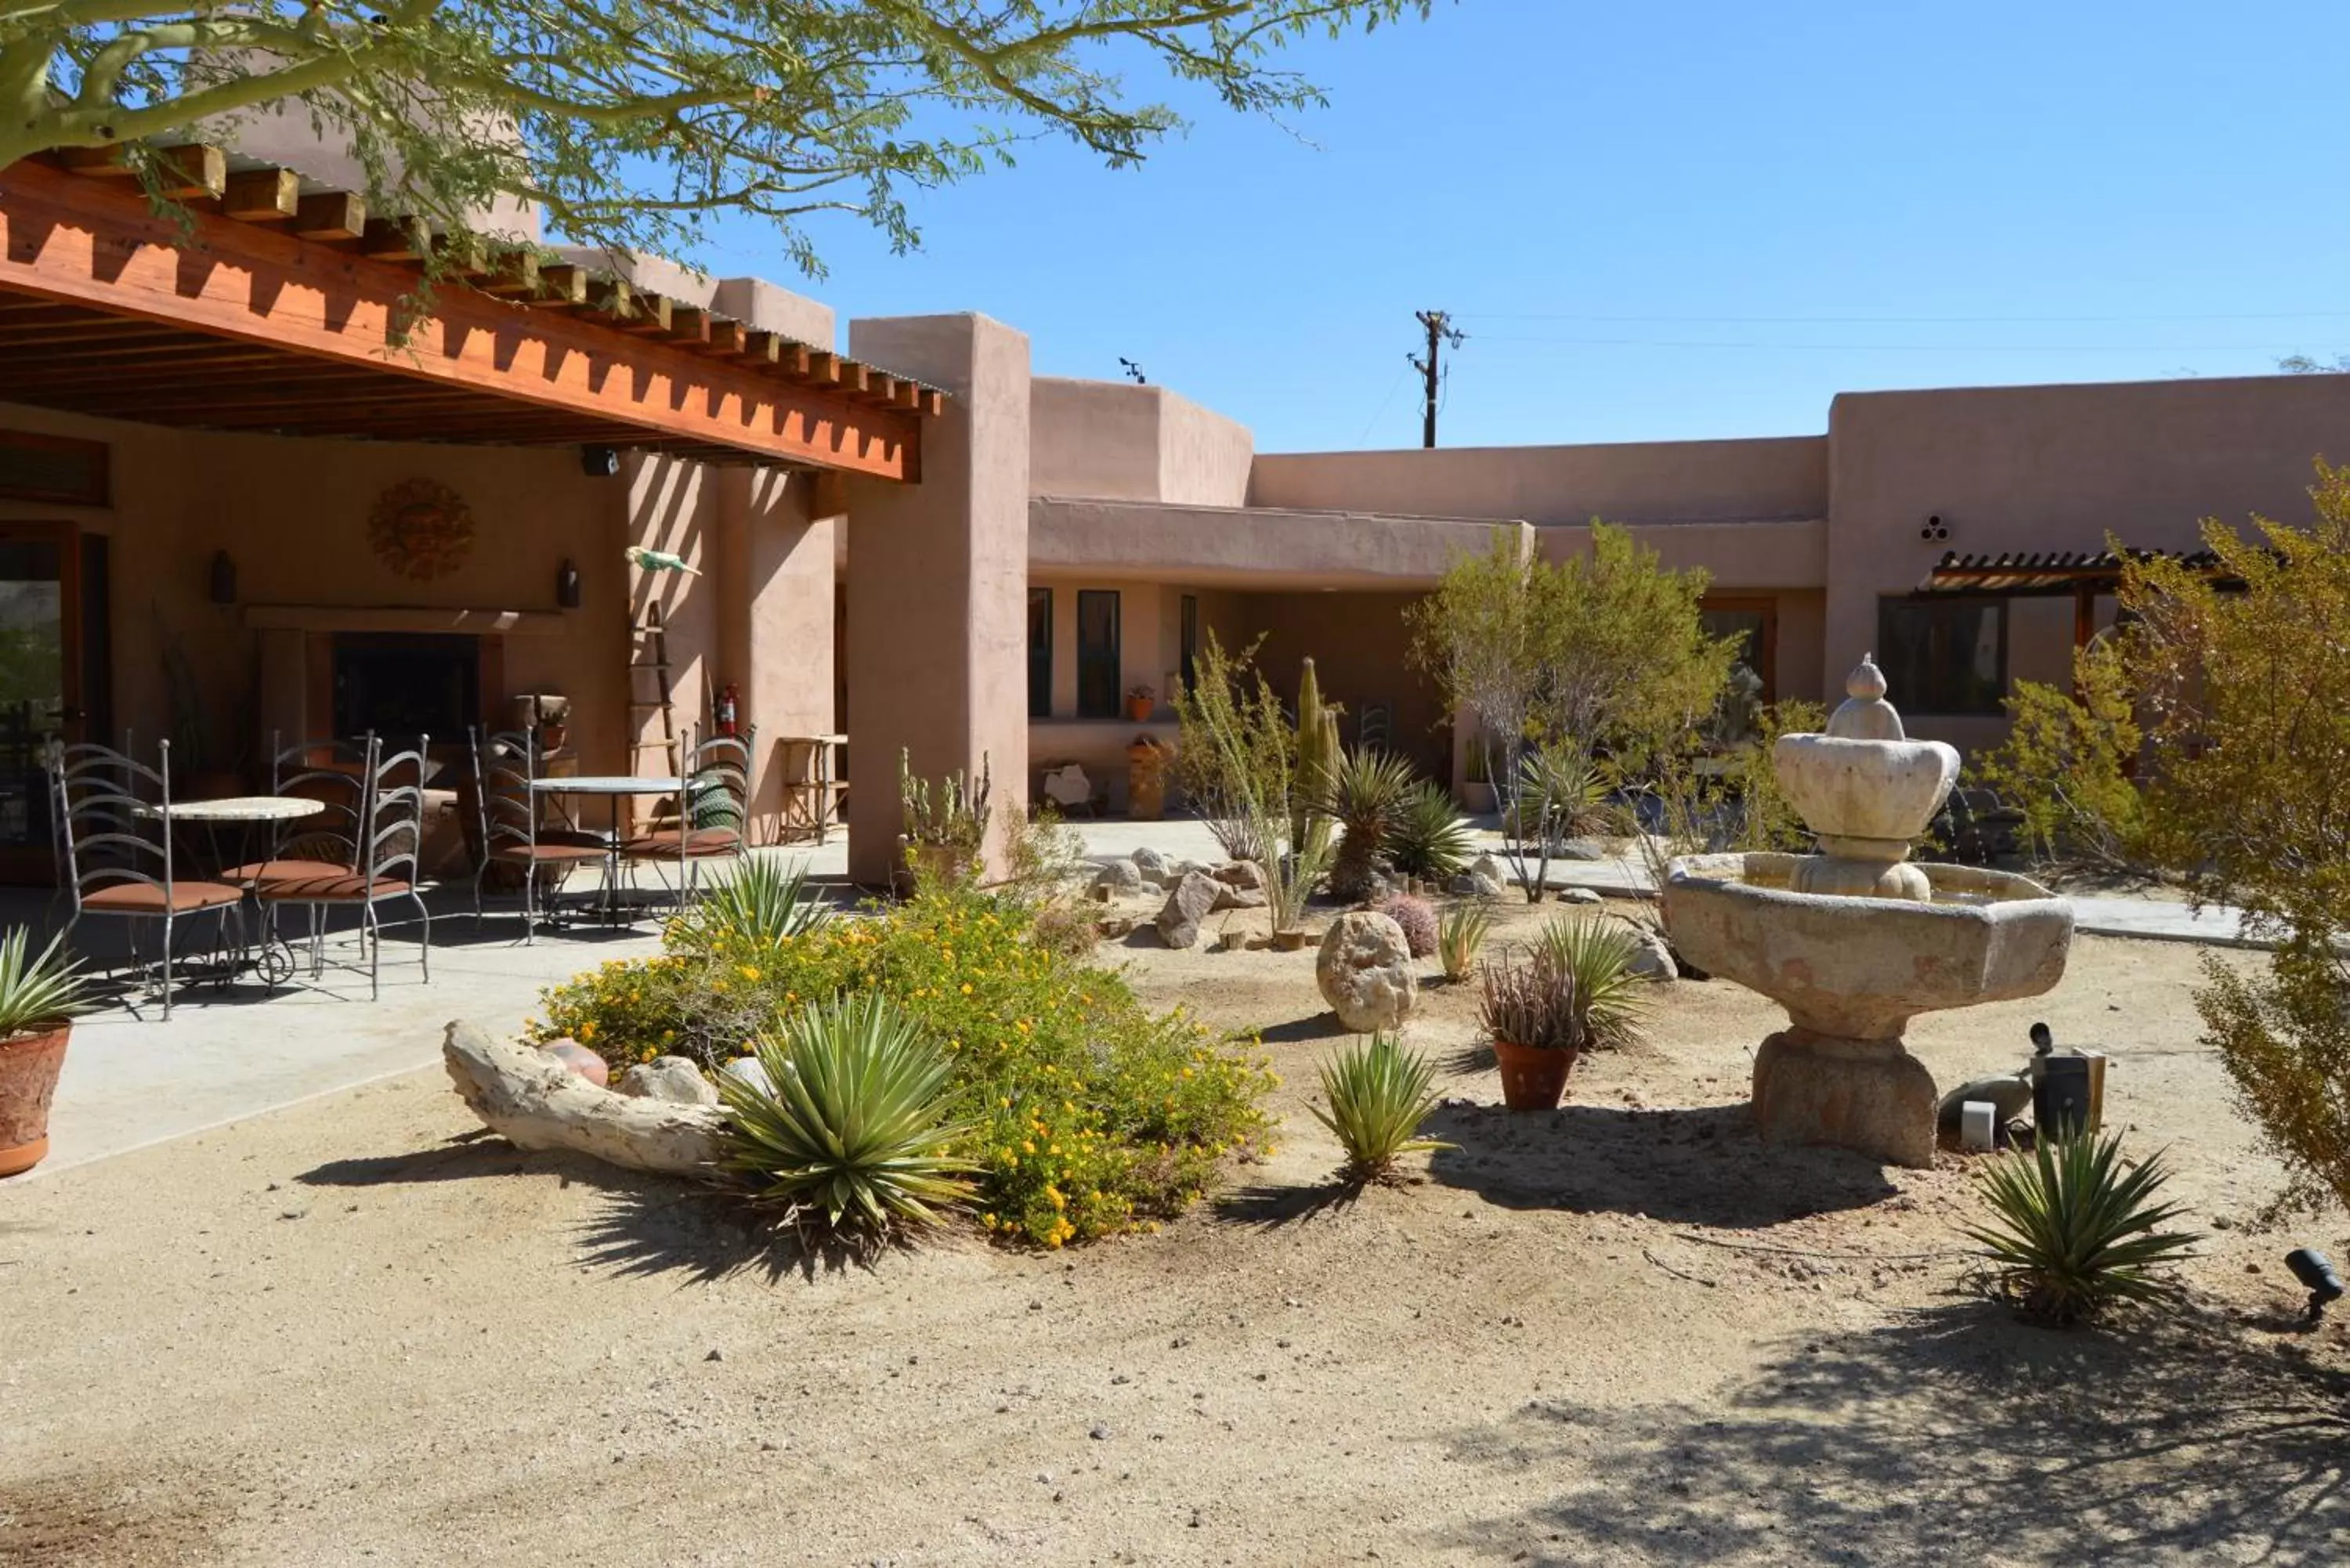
[1478,919,1645,1110]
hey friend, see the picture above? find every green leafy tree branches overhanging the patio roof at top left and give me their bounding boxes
[0,0,1434,273]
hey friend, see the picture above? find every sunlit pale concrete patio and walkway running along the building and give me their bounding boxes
[0,818,2249,1183]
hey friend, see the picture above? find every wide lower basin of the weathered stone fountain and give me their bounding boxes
[1661,851,2073,1042]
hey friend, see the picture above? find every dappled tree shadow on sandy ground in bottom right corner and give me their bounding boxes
[1443,1305,2350,1568]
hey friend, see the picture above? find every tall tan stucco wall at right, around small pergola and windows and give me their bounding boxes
[1824,376,2350,747]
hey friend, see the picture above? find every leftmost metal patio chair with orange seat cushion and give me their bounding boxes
[49,740,244,1023]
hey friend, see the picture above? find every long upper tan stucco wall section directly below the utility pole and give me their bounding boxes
[1248,435,1828,524]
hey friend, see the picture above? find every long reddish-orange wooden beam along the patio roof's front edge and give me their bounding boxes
[0,160,921,479]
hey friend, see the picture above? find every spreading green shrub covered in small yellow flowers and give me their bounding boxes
[531,889,1274,1246]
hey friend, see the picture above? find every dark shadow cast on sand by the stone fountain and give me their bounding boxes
[1422,1100,1899,1230]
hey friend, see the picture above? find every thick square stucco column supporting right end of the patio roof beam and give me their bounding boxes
[846,315,1029,884]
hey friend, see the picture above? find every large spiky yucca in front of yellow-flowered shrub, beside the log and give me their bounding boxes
[719,992,973,1248]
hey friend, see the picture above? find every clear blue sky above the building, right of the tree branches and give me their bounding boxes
[707,0,2350,451]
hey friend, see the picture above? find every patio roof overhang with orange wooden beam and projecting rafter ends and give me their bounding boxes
[0,148,945,482]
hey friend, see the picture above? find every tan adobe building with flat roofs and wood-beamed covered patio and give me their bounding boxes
[0,150,2350,882]
